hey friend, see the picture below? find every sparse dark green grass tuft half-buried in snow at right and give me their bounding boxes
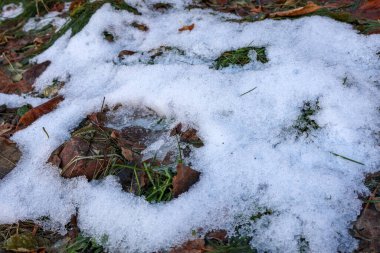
[293,99,321,137]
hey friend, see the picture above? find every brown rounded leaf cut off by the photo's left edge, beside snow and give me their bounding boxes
[0,137,21,179]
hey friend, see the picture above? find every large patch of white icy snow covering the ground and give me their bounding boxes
[0,1,380,252]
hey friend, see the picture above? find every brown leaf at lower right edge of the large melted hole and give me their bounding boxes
[173,163,201,198]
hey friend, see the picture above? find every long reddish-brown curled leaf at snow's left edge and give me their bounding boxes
[16,96,64,130]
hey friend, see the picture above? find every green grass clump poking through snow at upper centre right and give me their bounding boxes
[214,47,268,69]
